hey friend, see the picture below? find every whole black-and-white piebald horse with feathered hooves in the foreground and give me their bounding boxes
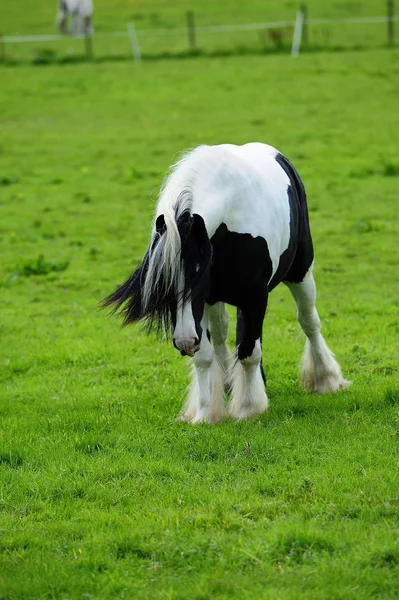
[103,143,349,423]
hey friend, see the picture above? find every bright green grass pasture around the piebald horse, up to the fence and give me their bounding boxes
[0,49,399,600]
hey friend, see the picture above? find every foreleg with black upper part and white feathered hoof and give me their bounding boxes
[229,293,268,419]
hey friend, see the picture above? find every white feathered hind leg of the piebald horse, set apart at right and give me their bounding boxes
[284,268,351,394]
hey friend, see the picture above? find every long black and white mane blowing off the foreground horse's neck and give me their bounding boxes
[101,149,212,335]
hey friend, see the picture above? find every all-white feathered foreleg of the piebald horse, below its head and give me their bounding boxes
[180,309,227,424]
